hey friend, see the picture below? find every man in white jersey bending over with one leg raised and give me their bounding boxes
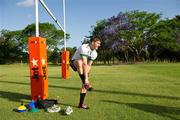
[70,36,101,109]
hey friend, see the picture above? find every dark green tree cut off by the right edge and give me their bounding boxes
[148,18,180,59]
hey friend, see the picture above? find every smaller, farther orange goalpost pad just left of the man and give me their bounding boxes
[61,51,69,79]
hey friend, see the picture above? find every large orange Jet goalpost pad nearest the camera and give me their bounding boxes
[28,37,48,100]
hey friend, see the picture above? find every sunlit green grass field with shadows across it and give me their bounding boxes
[0,63,180,120]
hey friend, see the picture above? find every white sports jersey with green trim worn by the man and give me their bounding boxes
[72,44,97,61]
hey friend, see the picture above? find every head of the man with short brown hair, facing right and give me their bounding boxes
[90,36,101,50]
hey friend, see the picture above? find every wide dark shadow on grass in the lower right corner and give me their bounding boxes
[102,100,180,120]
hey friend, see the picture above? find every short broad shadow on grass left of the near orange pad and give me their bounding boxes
[0,91,31,102]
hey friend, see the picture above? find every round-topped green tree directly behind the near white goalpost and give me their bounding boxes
[20,23,69,50]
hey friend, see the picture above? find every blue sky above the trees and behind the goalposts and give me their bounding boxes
[0,0,180,47]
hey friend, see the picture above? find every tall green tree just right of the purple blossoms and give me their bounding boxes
[119,11,160,61]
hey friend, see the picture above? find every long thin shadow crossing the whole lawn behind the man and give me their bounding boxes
[0,81,180,100]
